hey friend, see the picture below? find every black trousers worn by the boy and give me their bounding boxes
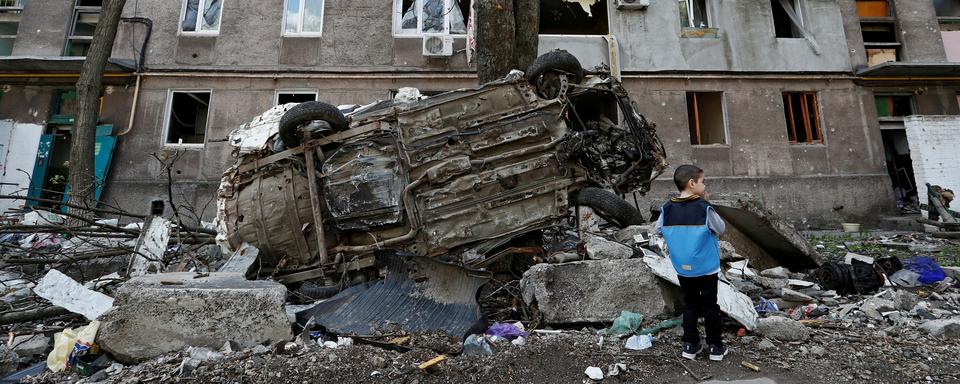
[677,273,723,345]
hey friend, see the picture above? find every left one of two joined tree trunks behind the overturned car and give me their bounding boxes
[475,0,515,84]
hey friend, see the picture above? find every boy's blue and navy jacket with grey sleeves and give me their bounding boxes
[657,195,726,277]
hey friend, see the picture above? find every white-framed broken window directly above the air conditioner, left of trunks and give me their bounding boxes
[393,0,470,36]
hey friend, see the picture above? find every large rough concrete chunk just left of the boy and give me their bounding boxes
[520,259,679,324]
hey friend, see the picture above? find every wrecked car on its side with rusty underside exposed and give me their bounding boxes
[217,50,666,284]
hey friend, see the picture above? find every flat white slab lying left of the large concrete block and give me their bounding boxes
[33,269,113,320]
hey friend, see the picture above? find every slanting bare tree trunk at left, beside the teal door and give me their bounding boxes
[68,0,126,222]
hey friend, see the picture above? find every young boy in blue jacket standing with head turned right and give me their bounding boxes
[657,165,727,361]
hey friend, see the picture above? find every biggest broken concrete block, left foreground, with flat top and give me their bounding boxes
[97,272,291,363]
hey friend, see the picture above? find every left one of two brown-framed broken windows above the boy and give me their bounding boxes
[687,92,727,145]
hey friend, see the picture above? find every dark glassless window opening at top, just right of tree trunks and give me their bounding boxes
[539,0,609,35]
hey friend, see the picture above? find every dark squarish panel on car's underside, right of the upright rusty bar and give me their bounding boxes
[323,136,406,230]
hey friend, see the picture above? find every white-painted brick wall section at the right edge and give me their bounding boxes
[904,116,960,198]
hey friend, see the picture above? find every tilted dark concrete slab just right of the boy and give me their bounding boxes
[710,193,825,270]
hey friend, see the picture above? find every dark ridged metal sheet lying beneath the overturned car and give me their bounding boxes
[297,250,490,340]
